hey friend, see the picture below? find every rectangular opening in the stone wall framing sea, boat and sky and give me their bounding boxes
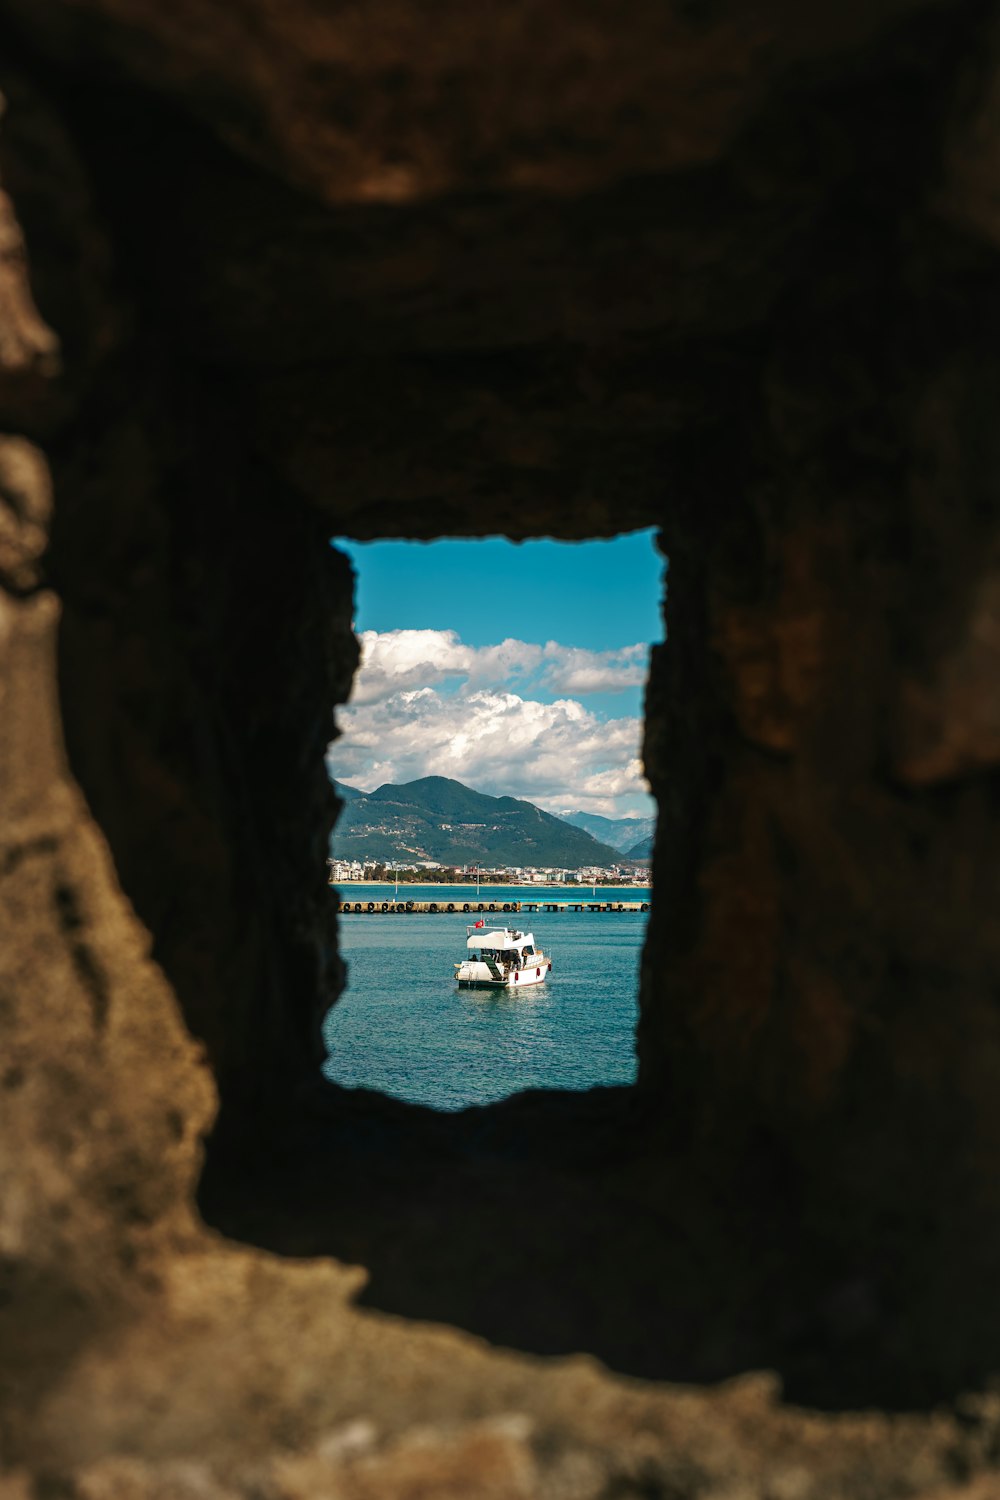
[324,531,663,1110]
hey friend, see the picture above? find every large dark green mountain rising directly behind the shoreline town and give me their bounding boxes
[330,776,622,870]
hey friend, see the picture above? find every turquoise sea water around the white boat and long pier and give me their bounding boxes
[324,885,649,1110]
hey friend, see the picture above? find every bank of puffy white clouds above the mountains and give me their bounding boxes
[328,630,648,818]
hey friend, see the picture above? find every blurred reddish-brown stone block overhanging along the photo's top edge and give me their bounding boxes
[4,0,941,203]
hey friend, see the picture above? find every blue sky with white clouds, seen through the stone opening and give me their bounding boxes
[328,531,664,818]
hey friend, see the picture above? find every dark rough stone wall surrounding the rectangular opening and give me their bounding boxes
[0,0,1000,1500]
